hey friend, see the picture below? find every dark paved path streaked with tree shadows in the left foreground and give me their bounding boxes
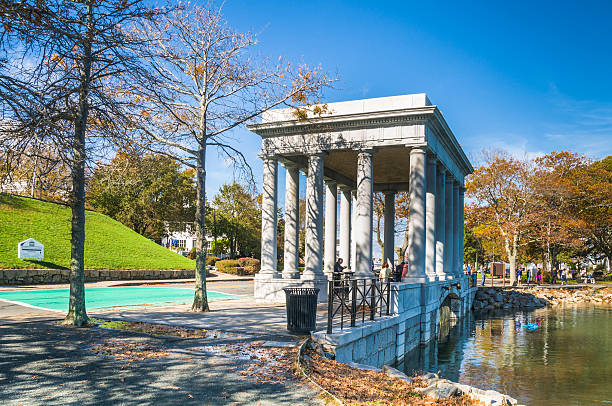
[0,322,317,406]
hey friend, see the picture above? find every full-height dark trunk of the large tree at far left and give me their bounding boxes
[64,3,93,327]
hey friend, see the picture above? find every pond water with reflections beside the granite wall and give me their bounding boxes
[404,306,612,405]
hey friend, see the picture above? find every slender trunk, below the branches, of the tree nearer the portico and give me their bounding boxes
[191,136,210,312]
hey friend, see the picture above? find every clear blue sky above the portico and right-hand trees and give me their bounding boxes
[207,0,612,196]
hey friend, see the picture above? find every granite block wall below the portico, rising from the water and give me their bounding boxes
[312,277,477,368]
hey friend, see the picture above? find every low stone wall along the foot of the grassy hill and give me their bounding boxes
[0,269,195,285]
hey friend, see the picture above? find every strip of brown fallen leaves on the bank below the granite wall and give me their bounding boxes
[305,351,478,406]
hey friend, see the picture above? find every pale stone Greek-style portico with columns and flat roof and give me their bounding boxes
[249,94,473,302]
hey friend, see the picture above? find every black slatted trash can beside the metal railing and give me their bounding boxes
[283,288,319,334]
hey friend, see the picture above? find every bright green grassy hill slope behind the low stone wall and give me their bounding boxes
[0,194,195,269]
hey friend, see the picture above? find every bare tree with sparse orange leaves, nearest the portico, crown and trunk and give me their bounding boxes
[126,3,331,311]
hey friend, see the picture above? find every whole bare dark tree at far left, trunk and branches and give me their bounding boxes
[0,0,156,326]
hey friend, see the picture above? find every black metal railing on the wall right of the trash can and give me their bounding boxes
[327,278,391,334]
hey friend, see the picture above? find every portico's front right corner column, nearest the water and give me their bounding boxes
[407,148,426,282]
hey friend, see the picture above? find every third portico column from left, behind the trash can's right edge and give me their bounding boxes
[302,154,325,280]
